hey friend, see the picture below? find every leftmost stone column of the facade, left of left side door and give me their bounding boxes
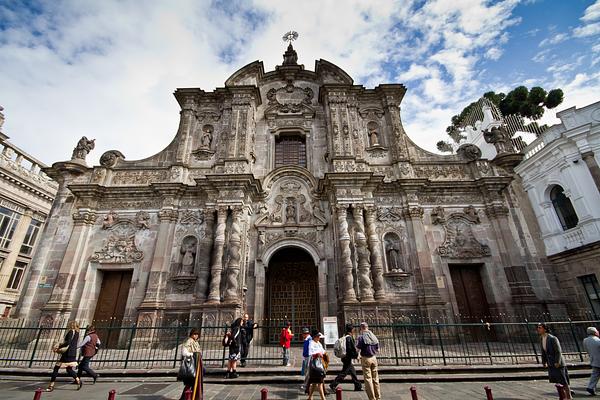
[43,210,96,319]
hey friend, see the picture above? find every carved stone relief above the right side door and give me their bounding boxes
[438,214,491,259]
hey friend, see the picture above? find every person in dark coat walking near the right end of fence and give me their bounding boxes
[537,323,572,399]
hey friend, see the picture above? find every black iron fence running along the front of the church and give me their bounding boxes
[0,320,600,369]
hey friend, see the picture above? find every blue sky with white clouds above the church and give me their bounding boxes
[0,0,600,165]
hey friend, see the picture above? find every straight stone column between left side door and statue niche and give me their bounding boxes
[139,208,179,310]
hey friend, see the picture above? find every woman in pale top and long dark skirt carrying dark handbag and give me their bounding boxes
[177,329,204,400]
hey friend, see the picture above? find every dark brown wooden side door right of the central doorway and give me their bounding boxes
[450,264,490,340]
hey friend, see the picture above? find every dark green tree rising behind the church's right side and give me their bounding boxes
[437,86,564,152]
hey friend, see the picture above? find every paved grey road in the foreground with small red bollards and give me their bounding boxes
[0,377,588,400]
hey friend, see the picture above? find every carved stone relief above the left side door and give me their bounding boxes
[91,221,144,264]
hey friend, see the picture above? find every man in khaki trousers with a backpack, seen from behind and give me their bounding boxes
[356,322,381,400]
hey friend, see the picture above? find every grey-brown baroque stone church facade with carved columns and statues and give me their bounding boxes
[19,44,562,332]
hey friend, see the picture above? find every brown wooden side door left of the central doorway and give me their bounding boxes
[94,271,132,347]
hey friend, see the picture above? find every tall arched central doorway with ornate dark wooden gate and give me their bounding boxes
[265,247,319,343]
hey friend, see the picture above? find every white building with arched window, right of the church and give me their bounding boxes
[515,102,600,318]
